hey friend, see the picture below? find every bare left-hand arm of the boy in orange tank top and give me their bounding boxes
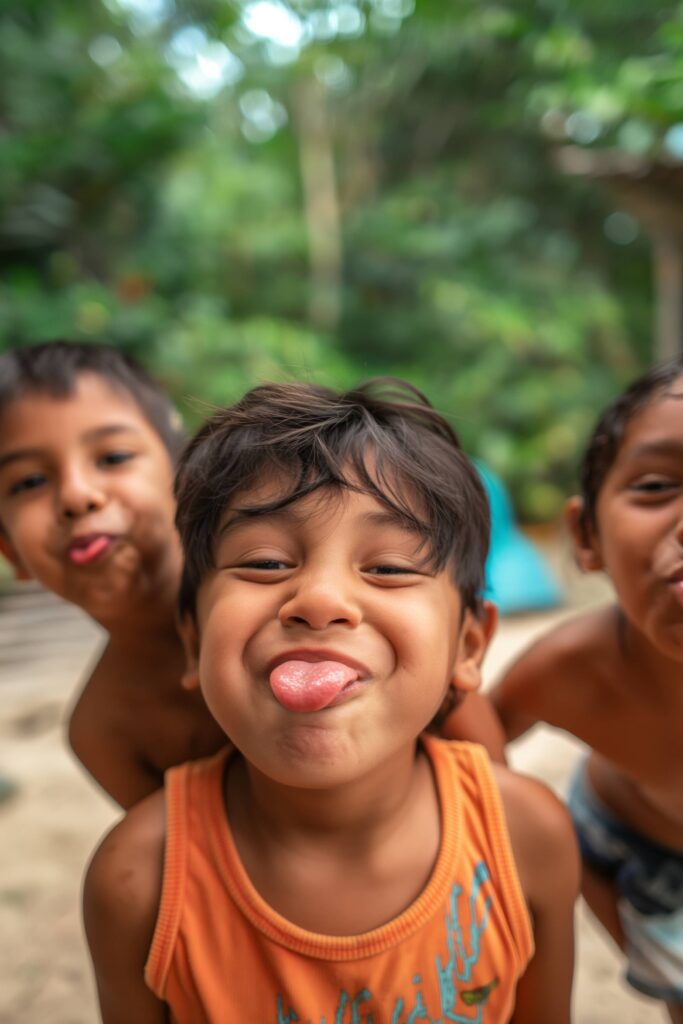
[83,793,167,1024]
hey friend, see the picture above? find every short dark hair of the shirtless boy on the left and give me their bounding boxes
[0,341,186,462]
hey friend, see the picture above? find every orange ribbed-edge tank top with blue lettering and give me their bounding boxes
[145,738,533,1024]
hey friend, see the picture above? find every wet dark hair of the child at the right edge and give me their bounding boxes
[580,355,683,540]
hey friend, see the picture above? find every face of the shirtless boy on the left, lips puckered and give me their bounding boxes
[0,373,179,623]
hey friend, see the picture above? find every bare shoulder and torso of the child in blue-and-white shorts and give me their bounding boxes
[493,606,683,849]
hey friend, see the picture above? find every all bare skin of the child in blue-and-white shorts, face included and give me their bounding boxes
[492,380,683,1022]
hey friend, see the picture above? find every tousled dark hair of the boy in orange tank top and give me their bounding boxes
[175,378,489,612]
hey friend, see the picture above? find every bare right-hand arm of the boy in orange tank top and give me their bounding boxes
[497,768,581,1024]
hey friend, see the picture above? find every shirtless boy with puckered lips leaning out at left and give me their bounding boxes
[0,342,225,807]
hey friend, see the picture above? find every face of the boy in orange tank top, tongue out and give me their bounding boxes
[185,477,488,788]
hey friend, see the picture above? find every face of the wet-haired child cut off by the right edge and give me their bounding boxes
[585,378,683,662]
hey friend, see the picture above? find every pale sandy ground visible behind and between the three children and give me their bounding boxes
[0,569,668,1024]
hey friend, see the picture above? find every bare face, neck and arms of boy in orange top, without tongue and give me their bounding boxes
[84,485,579,1024]
